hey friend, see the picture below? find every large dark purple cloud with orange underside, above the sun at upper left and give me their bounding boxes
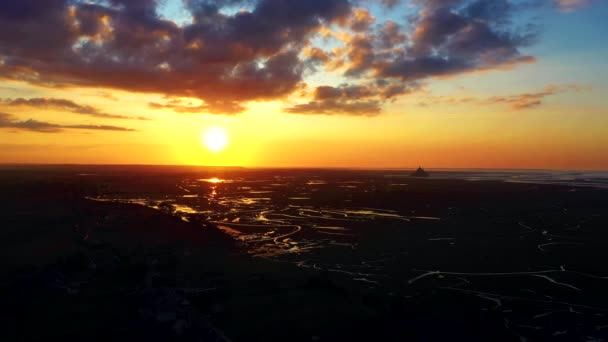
[0,0,351,113]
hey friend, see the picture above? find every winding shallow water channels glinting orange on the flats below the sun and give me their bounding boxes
[94,177,432,257]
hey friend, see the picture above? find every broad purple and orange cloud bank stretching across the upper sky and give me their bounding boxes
[0,0,556,115]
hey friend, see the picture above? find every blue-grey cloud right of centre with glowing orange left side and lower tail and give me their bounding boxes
[296,0,536,115]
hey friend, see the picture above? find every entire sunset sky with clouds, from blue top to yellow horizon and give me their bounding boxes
[0,0,608,170]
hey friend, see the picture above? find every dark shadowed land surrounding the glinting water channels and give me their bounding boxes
[0,166,608,341]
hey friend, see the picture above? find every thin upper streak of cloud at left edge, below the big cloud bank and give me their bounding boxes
[0,98,148,120]
